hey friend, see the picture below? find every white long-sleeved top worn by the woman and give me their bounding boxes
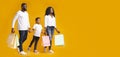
[45,15,56,28]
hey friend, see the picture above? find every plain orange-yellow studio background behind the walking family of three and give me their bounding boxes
[0,0,120,57]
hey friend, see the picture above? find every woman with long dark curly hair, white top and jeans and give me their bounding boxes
[44,7,60,53]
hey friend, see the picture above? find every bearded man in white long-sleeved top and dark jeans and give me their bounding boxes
[11,3,30,55]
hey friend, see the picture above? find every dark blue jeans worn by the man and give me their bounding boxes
[18,30,28,52]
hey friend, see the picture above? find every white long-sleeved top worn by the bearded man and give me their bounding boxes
[12,10,30,30]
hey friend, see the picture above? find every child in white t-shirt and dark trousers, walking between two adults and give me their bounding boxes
[28,17,42,53]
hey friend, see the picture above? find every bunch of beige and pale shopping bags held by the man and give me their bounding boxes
[7,34,19,49]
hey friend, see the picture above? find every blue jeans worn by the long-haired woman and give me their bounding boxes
[46,26,54,50]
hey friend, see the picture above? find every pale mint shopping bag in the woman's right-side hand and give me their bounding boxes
[54,34,64,46]
